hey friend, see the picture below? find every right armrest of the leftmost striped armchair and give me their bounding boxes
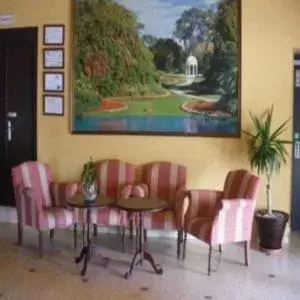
[50,181,79,206]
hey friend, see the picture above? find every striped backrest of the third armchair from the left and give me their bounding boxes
[143,162,186,208]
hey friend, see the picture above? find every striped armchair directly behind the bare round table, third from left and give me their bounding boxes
[133,162,187,258]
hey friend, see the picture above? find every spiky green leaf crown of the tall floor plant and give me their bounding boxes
[244,107,292,180]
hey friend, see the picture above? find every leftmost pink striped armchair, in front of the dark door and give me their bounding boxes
[12,161,78,257]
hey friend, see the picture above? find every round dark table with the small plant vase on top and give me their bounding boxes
[67,194,115,276]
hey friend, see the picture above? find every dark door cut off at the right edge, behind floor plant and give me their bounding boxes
[291,54,300,230]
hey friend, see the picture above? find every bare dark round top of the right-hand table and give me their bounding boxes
[114,197,168,212]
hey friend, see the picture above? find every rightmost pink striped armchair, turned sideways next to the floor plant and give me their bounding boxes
[183,170,259,275]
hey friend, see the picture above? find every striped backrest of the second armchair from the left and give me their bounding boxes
[96,159,135,198]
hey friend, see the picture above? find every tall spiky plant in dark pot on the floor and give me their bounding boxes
[244,106,292,251]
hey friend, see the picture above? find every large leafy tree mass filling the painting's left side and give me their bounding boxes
[74,0,160,114]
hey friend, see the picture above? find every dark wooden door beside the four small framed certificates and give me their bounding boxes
[0,28,38,206]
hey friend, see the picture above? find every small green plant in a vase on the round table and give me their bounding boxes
[81,158,97,201]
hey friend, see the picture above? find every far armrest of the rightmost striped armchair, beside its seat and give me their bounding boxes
[186,189,223,220]
